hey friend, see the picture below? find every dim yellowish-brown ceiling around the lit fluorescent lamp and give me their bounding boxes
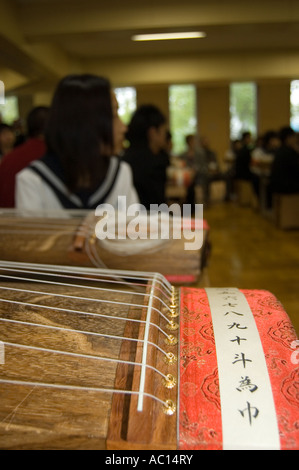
[0,0,299,91]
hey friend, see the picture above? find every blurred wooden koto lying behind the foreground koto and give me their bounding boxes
[0,209,208,284]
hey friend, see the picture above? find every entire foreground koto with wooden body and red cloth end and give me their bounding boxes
[0,262,299,450]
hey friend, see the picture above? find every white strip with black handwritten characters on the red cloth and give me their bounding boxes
[205,288,280,450]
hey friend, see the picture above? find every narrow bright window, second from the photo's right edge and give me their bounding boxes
[230,82,257,140]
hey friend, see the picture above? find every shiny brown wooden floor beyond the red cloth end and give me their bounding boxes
[198,203,299,336]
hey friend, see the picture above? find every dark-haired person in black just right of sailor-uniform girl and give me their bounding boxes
[123,104,169,210]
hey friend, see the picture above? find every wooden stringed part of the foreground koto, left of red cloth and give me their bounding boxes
[0,264,178,449]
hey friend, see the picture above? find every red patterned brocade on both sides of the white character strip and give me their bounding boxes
[179,287,299,450]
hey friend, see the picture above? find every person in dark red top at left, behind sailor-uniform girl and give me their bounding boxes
[0,106,49,207]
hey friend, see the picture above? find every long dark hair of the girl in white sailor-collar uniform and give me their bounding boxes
[45,74,113,192]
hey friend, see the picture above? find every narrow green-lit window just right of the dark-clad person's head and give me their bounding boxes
[169,85,197,155]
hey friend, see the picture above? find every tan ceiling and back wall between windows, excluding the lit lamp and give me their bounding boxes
[0,0,299,159]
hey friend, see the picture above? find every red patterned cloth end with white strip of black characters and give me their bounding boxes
[179,288,299,449]
